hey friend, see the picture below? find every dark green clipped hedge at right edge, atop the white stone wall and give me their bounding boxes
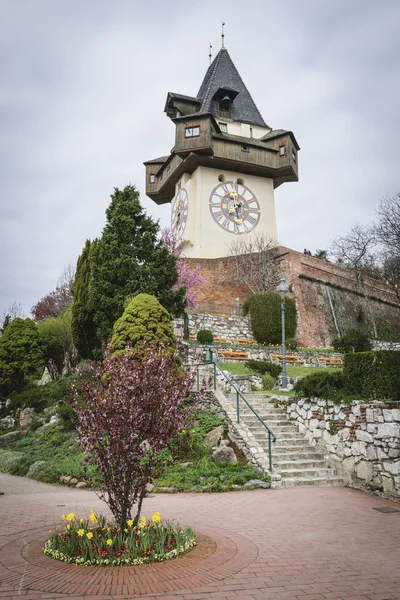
[344,350,400,401]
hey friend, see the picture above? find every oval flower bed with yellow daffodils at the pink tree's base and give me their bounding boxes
[43,510,196,566]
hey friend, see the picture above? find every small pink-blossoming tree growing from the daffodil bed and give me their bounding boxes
[75,347,195,529]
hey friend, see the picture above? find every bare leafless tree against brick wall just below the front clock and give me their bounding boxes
[228,233,280,294]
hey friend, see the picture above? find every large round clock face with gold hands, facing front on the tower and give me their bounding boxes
[209,181,261,235]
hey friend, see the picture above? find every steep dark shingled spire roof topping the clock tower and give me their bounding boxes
[197,48,268,127]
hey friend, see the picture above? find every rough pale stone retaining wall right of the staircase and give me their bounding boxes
[287,399,400,499]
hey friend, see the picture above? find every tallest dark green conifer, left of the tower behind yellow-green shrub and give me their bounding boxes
[89,185,185,343]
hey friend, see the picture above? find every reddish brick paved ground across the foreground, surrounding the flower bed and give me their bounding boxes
[0,475,400,600]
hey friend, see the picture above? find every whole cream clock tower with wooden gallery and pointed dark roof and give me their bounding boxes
[144,48,300,259]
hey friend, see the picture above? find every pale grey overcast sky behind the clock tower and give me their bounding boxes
[0,0,400,316]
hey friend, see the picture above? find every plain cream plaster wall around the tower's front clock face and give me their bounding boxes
[171,167,277,258]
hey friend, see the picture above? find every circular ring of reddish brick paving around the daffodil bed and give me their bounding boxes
[0,528,258,597]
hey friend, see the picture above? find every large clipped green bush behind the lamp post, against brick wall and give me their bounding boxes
[243,292,296,344]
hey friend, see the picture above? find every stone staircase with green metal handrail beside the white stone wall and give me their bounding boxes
[240,394,344,487]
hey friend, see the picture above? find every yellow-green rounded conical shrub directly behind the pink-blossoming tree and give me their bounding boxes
[111,294,176,355]
